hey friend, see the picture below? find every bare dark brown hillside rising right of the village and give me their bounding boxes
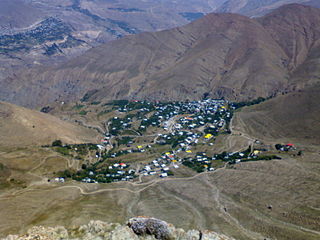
[235,85,320,145]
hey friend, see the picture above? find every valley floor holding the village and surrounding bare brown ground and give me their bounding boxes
[0,96,320,239]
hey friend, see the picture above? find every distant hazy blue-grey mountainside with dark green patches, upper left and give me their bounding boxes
[0,0,226,80]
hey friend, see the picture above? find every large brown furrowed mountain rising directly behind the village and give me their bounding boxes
[0,4,320,107]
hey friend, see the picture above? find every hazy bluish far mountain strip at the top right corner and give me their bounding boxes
[216,0,319,17]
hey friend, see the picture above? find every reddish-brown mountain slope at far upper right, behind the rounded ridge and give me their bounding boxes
[258,4,320,70]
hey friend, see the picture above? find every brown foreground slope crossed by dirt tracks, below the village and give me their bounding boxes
[0,153,320,240]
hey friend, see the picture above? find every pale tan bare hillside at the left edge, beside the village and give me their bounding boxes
[0,102,97,147]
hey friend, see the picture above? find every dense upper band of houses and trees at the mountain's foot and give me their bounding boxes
[108,99,231,135]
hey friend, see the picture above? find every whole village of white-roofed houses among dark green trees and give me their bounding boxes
[50,99,292,183]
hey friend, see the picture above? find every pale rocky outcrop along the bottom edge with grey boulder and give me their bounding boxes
[3,217,232,240]
